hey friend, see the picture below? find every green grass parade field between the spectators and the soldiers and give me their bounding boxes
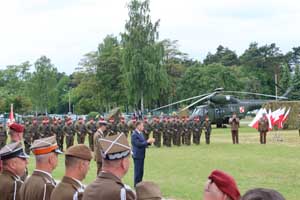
[29,126,300,200]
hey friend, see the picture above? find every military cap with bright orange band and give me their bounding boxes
[30,136,62,155]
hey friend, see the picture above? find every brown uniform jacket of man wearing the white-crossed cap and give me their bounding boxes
[83,172,136,200]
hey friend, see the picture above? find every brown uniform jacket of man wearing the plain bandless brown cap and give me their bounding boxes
[51,176,84,200]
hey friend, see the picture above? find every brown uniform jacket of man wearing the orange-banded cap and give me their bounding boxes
[20,170,56,200]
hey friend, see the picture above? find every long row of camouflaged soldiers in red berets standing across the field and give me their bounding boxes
[0,116,211,154]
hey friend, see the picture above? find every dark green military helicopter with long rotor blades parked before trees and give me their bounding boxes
[151,88,289,128]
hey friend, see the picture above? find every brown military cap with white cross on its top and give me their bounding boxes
[99,133,131,160]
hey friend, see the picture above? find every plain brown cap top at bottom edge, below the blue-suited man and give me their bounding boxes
[135,181,163,200]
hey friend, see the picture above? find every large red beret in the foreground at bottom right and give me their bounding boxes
[208,170,241,200]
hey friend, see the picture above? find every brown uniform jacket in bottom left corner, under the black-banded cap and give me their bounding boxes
[0,170,23,200]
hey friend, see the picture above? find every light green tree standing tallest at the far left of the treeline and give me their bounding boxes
[30,56,57,113]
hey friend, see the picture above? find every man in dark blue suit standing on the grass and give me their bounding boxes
[131,121,155,186]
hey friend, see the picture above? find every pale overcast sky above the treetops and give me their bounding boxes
[0,0,300,74]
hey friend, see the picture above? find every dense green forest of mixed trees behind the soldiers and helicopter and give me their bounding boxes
[0,0,300,114]
